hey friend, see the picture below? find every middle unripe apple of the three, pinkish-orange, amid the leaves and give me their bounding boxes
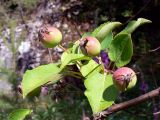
[80,36,101,57]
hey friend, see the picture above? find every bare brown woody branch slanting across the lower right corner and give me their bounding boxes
[95,87,160,120]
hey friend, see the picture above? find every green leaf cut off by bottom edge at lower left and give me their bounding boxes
[9,109,32,120]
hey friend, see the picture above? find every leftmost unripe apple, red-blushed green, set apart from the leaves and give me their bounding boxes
[38,26,62,48]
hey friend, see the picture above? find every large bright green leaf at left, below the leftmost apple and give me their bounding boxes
[22,64,62,97]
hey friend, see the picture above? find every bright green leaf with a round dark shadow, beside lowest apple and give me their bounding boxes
[84,72,118,114]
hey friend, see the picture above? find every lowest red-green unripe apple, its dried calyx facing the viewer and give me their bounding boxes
[113,67,137,91]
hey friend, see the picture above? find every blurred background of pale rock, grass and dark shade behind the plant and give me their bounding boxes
[0,0,160,120]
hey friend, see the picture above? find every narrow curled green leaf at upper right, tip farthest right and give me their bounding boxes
[121,18,152,34]
